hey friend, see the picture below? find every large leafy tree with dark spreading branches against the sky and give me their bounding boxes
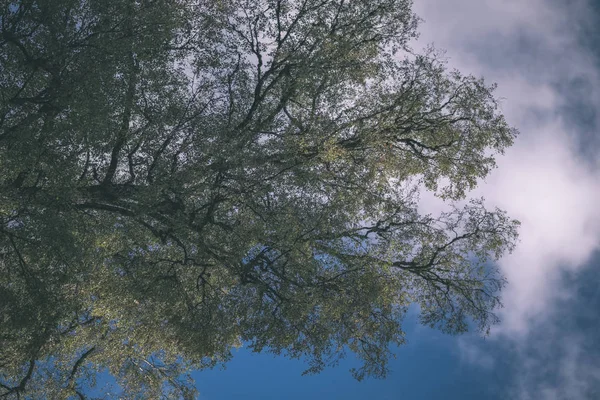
[0,0,517,398]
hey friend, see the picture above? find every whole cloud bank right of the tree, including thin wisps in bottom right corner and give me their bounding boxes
[414,0,600,399]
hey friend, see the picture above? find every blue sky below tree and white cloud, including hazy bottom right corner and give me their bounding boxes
[194,257,600,400]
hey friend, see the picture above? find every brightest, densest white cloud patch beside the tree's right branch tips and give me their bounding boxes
[480,121,600,333]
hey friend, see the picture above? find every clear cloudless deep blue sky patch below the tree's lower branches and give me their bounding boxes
[195,312,506,400]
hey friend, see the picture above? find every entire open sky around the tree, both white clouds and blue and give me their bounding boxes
[195,0,600,400]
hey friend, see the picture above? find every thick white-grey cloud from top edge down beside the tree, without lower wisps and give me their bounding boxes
[415,0,600,334]
